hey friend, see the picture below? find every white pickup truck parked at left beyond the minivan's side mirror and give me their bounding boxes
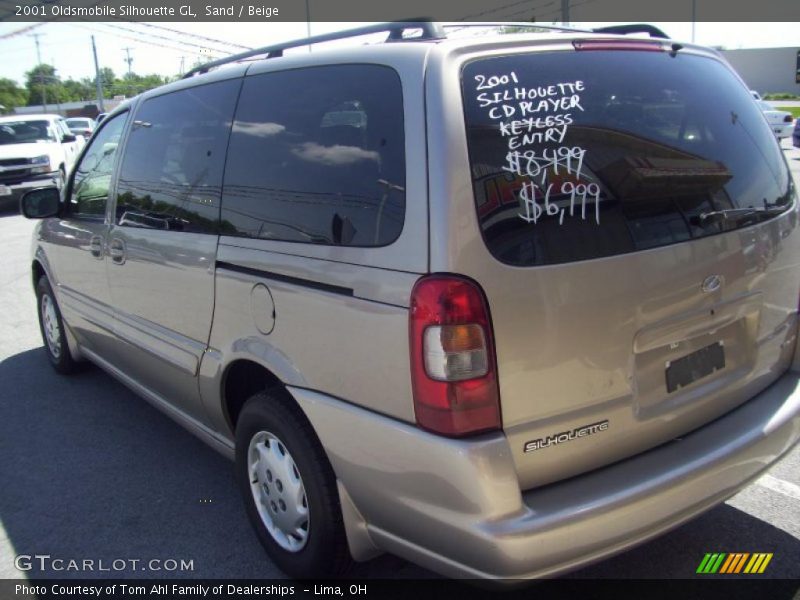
[0,115,82,211]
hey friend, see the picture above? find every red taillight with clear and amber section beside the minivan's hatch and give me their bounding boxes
[409,275,500,437]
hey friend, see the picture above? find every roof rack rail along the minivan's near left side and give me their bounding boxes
[183,19,445,79]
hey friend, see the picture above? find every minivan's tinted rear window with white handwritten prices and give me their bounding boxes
[462,46,794,266]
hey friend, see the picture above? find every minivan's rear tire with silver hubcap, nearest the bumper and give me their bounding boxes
[235,388,352,579]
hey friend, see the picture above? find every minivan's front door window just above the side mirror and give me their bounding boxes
[67,112,128,219]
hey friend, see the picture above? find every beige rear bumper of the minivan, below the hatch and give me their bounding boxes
[291,372,800,579]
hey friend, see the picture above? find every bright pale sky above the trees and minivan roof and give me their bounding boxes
[0,21,800,83]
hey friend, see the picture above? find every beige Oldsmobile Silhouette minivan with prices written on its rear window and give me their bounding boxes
[22,22,800,580]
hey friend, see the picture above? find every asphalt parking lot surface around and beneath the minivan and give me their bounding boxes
[0,140,800,579]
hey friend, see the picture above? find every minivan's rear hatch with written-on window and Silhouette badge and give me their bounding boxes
[459,40,799,489]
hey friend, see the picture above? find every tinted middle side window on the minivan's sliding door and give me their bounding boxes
[116,80,241,233]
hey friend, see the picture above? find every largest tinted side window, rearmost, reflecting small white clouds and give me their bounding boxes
[220,65,406,246]
